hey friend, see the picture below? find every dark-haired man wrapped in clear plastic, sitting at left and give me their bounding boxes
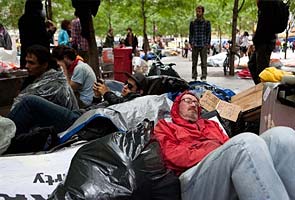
[11,45,78,110]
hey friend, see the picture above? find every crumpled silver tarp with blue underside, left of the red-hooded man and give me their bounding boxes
[59,94,173,143]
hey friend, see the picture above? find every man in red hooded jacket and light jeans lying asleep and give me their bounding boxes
[154,91,295,200]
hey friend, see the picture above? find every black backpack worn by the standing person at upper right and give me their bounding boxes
[273,0,290,33]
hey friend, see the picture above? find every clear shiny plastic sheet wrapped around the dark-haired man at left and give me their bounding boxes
[11,69,78,110]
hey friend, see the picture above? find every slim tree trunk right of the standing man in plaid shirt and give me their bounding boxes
[229,0,239,76]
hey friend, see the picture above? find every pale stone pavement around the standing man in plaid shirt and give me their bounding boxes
[158,55,254,94]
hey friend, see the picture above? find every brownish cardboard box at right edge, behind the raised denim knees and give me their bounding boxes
[259,84,295,134]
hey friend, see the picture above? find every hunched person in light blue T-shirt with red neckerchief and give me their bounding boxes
[52,46,96,108]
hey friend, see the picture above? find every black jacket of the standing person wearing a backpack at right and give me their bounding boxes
[253,0,278,45]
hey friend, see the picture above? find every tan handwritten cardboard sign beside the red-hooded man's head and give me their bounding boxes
[200,90,241,122]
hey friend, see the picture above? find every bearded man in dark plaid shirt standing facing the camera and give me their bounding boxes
[189,6,211,81]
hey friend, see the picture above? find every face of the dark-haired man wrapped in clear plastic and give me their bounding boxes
[26,53,48,77]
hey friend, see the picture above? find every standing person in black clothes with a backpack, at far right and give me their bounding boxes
[248,0,278,85]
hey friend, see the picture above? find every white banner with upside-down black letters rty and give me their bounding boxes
[0,146,81,200]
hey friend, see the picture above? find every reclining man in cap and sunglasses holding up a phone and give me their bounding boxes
[7,73,147,152]
